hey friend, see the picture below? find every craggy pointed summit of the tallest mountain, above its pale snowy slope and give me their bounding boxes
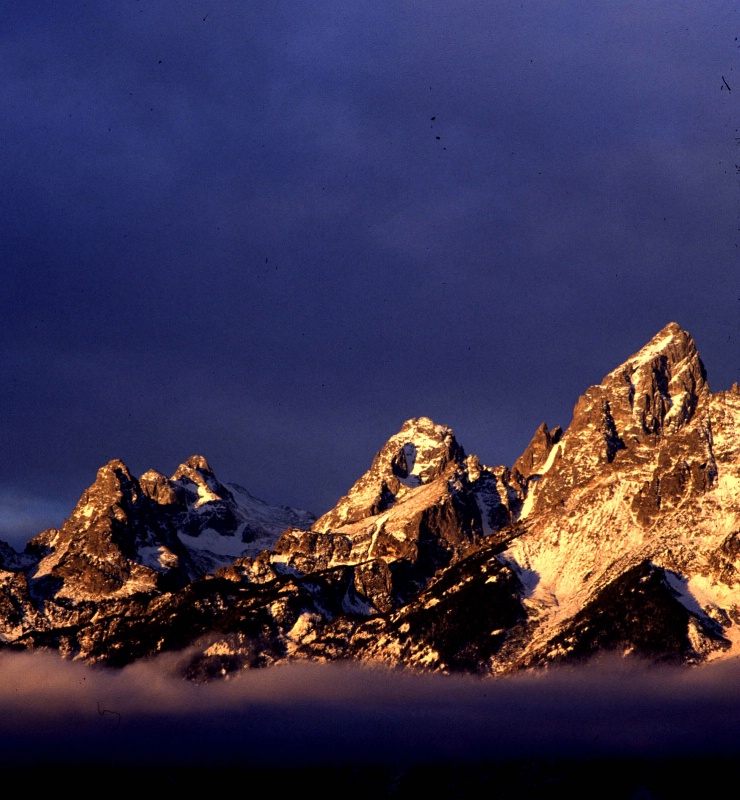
[517,322,713,516]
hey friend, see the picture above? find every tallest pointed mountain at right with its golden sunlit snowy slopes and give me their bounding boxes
[488,324,740,661]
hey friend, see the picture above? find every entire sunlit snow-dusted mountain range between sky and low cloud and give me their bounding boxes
[0,323,740,681]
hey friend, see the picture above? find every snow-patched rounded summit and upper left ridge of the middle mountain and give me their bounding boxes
[312,417,465,532]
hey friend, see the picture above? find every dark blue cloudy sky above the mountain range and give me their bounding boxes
[0,0,740,540]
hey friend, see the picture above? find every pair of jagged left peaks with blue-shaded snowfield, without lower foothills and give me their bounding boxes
[14,456,314,608]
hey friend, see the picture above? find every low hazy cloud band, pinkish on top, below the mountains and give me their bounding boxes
[0,653,740,766]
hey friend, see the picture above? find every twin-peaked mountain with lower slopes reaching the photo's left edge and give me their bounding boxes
[0,456,315,651]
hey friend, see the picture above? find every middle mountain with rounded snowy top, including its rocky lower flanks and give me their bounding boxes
[258,417,521,611]
